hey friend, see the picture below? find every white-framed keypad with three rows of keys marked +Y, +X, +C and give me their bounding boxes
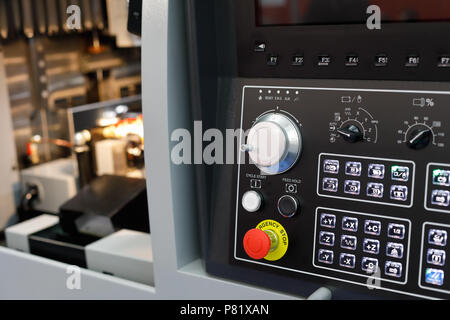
[314,208,411,284]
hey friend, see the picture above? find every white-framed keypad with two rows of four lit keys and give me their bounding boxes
[317,154,414,208]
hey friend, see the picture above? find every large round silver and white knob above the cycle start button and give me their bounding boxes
[243,112,302,175]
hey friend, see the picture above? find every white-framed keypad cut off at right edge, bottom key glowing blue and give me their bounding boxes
[419,222,450,293]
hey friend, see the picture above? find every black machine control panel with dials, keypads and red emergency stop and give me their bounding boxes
[230,80,450,298]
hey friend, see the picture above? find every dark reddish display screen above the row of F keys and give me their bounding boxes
[256,0,450,26]
